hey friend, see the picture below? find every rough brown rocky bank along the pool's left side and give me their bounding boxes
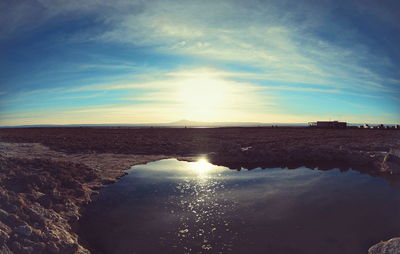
[0,142,178,254]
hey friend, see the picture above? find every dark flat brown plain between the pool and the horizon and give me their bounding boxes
[0,128,400,171]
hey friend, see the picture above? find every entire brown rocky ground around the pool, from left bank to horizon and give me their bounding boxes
[0,127,400,253]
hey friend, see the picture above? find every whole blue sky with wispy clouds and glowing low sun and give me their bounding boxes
[0,0,400,126]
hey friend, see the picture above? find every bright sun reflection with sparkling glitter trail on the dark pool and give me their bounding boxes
[171,157,234,253]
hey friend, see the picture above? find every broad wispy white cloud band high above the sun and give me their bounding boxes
[79,1,396,93]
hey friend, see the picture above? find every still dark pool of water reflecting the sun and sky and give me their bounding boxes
[79,159,400,254]
